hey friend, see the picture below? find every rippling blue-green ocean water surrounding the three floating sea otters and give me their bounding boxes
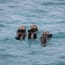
[0,0,65,65]
